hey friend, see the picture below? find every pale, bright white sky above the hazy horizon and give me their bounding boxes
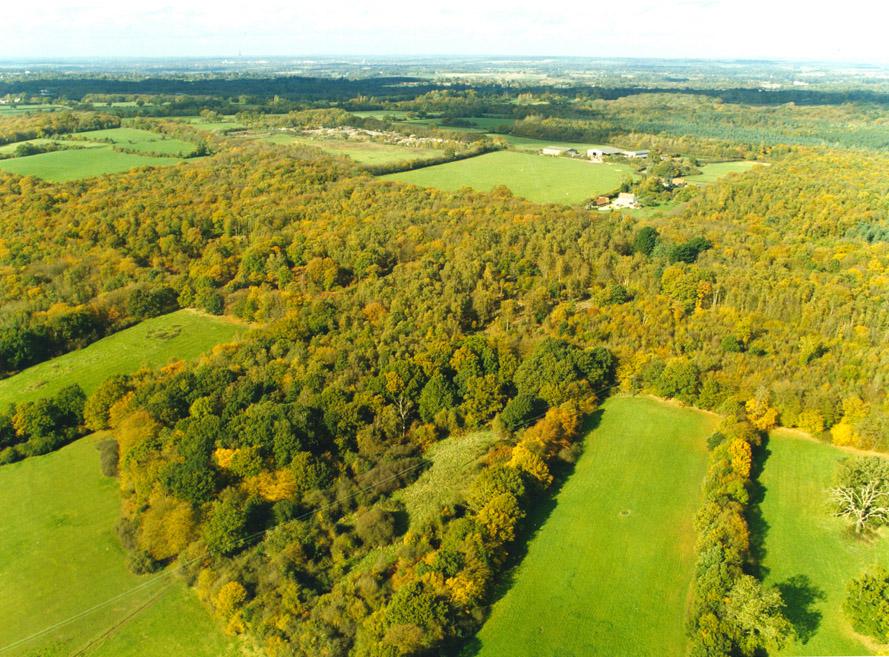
[6,0,889,64]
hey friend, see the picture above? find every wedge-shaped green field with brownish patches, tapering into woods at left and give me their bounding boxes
[0,310,244,405]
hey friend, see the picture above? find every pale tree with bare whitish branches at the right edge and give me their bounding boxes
[830,457,889,534]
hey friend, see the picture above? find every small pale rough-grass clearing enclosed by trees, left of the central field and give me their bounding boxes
[397,431,497,528]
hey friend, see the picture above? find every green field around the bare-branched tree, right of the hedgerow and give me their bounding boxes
[759,430,889,655]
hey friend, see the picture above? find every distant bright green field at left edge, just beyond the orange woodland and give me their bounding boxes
[0,146,182,182]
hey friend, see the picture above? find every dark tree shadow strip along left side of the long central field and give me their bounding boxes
[450,408,603,657]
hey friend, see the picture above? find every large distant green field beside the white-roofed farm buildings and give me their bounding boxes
[383,151,633,204]
